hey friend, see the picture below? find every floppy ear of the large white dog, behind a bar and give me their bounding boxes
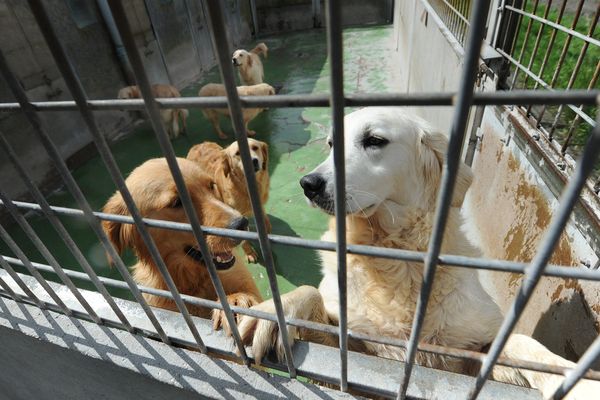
[419,132,473,207]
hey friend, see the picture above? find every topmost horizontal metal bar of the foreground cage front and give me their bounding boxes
[0,90,600,112]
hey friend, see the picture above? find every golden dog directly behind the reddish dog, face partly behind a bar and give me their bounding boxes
[186,139,271,262]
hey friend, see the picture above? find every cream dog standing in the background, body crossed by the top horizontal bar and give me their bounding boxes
[198,83,275,139]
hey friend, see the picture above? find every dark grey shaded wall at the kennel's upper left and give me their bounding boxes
[0,0,251,206]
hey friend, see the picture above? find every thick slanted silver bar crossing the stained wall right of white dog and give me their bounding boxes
[469,113,600,400]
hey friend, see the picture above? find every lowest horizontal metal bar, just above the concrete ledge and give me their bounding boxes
[0,256,600,381]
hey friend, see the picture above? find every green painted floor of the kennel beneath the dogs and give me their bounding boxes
[0,26,394,298]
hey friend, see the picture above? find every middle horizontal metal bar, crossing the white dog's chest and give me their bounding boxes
[0,201,600,282]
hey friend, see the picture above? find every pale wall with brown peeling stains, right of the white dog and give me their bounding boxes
[394,0,600,368]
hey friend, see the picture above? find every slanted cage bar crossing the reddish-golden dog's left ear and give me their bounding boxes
[29,0,207,353]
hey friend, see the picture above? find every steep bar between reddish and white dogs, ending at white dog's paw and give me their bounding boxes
[198,0,296,372]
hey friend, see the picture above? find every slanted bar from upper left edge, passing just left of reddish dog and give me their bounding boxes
[0,50,171,344]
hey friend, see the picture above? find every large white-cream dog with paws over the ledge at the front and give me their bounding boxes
[239,107,600,399]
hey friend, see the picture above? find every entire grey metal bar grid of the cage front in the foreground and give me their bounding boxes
[0,0,600,399]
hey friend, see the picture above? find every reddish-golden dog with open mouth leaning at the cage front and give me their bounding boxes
[102,158,262,328]
